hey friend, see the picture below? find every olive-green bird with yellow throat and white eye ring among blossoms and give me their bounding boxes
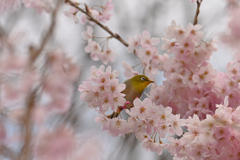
[108,75,154,119]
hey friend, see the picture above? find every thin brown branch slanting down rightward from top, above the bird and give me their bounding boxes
[65,0,128,47]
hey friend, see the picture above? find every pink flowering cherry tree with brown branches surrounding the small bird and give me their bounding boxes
[0,0,240,160]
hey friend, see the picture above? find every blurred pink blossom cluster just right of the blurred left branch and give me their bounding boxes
[42,49,80,113]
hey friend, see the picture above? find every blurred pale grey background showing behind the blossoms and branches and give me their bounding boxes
[0,0,233,160]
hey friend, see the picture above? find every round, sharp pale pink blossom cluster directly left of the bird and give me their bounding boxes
[78,65,126,114]
